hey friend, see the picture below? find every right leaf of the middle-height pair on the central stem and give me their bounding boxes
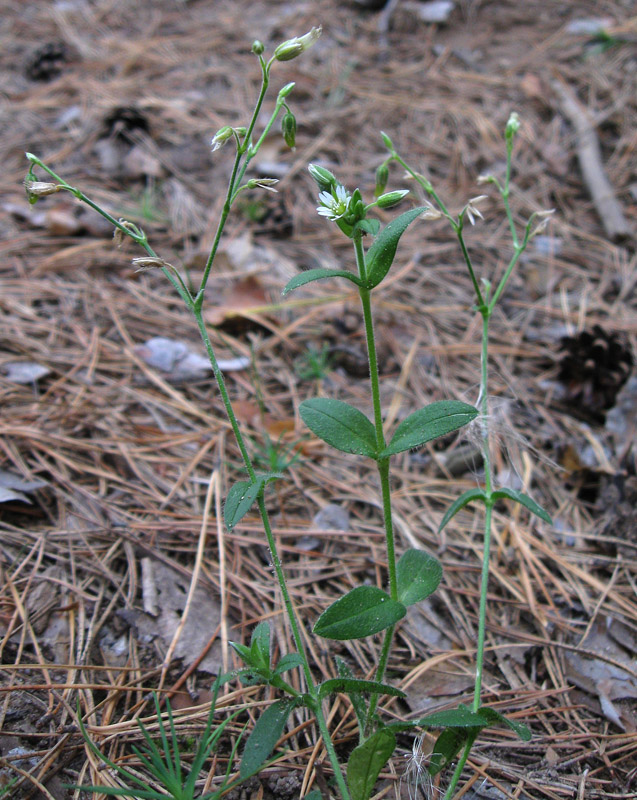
[380,400,478,458]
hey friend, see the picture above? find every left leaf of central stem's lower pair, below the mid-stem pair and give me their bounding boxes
[314,586,407,640]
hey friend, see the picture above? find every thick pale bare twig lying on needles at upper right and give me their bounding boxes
[552,79,631,242]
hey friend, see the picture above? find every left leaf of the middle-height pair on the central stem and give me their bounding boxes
[299,397,376,458]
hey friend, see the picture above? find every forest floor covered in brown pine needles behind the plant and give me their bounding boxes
[0,0,637,800]
